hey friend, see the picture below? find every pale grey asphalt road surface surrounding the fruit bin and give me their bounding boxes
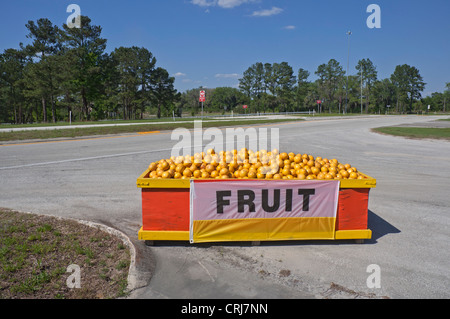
[0,116,450,299]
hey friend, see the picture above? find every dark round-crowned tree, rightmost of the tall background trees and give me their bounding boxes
[391,64,425,112]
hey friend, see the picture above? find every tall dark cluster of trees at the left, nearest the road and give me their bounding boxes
[0,16,179,124]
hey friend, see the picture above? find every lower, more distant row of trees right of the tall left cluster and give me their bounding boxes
[178,59,450,114]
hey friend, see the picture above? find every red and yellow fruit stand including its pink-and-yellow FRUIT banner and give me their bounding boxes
[137,150,376,243]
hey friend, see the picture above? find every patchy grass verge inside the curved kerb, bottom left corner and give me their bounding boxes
[0,209,130,299]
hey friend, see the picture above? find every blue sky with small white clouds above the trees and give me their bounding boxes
[0,0,450,96]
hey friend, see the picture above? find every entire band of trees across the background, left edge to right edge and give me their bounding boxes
[0,16,450,124]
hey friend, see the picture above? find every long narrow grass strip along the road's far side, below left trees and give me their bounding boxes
[0,119,302,141]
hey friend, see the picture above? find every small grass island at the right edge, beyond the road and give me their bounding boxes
[372,127,450,140]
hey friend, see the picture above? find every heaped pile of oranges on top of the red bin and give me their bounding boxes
[149,148,366,180]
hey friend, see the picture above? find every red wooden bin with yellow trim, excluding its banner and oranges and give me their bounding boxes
[137,170,376,244]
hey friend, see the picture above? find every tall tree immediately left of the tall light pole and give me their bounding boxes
[315,59,345,111]
